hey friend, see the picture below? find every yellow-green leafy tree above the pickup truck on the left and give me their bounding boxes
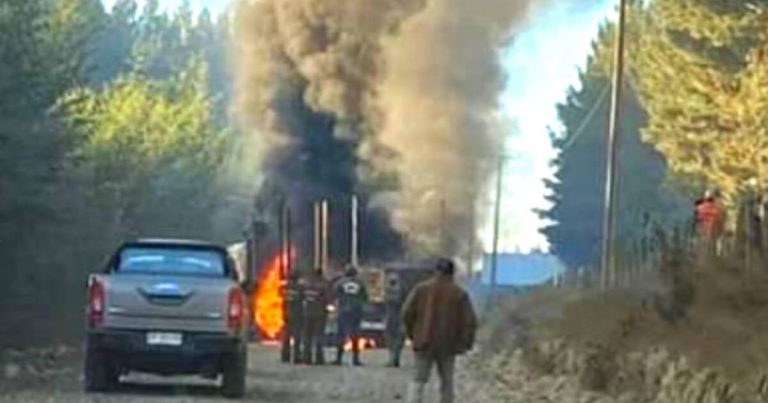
[61,62,227,236]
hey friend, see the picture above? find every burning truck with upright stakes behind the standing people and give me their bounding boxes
[232,196,431,349]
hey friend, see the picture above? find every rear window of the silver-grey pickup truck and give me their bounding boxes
[117,247,226,277]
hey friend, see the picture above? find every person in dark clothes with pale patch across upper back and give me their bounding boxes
[334,266,368,365]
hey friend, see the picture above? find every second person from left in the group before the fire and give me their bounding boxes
[304,269,331,365]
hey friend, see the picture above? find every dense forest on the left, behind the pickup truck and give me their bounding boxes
[0,0,250,346]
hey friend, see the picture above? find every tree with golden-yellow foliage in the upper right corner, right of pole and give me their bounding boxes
[616,0,768,202]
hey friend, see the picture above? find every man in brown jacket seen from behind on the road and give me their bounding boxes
[402,259,477,403]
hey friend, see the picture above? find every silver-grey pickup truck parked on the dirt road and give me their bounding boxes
[84,240,250,398]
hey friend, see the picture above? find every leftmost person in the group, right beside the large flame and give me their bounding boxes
[280,272,304,364]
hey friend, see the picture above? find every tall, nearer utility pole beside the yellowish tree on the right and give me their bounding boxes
[600,0,627,290]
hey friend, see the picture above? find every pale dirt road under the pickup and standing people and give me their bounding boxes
[0,346,487,403]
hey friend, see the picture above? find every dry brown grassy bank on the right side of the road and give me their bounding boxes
[486,254,768,390]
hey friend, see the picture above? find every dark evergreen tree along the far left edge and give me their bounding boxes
[0,0,103,342]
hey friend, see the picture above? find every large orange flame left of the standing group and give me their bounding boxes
[253,253,285,340]
